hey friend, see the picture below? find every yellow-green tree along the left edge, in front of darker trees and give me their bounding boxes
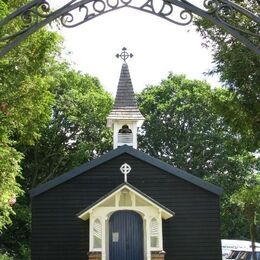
[0,0,61,232]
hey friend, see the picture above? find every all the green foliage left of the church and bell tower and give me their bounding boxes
[0,0,112,260]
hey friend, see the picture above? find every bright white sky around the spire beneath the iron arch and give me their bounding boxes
[49,0,220,95]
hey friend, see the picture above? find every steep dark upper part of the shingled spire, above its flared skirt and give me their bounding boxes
[114,62,137,108]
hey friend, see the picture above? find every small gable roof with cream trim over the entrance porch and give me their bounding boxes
[77,182,175,220]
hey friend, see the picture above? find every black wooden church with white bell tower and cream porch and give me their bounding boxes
[31,53,222,260]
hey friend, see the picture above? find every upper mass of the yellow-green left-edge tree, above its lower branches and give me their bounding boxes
[0,0,61,144]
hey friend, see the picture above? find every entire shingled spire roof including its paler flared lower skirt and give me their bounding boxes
[107,62,144,122]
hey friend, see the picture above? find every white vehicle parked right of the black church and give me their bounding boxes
[221,239,260,260]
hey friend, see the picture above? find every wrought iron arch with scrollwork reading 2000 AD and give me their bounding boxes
[0,0,260,57]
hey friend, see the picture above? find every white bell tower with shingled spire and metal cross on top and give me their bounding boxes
[107,48,144,149]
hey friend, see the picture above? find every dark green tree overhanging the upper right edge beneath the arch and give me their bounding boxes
[195,0,260,151]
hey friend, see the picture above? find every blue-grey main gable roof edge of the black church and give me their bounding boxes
[30,145,223,197]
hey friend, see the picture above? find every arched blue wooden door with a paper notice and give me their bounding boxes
[109,210,144,260]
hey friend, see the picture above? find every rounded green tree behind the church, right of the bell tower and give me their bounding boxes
[138,74,256,237]
